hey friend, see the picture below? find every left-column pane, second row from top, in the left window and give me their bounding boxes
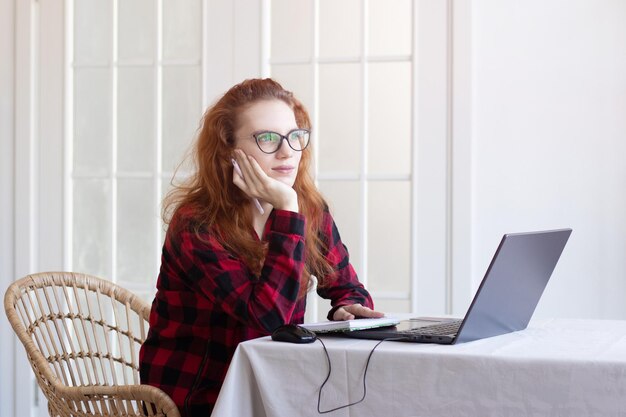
[73,68,113,176]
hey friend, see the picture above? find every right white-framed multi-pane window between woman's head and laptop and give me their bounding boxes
[264,0,414,319]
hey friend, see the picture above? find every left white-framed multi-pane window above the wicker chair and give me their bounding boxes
[66,0,203,300]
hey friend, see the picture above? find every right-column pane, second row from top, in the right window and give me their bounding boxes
[367,62,411,176]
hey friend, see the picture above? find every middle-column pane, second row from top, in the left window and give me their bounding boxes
[117,67,156,172]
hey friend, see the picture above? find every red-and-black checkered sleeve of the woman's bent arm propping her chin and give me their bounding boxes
[171,210,305,333]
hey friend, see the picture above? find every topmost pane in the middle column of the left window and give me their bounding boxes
[117,0,157,63]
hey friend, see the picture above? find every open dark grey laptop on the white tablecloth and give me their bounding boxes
[343,229,572,345]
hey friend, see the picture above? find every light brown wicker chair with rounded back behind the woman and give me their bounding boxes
[4,272,180,417]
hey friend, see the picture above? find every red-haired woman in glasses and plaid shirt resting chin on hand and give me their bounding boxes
[140,79,383,416]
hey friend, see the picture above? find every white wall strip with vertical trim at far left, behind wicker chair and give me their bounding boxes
[0,0,65,417]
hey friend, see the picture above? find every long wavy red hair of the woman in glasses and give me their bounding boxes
[162,78,333,295]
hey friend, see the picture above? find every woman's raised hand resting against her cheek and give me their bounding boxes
[233,149,298,212]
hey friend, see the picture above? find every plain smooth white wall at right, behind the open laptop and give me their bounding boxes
[472,0,626,319]
